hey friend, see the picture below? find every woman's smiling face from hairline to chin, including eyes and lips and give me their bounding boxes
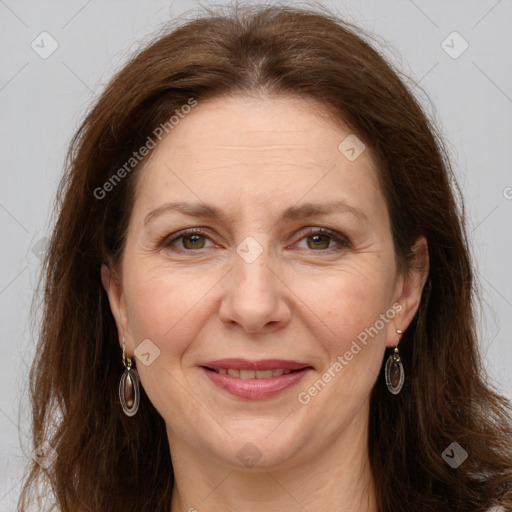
[102,97,422,467]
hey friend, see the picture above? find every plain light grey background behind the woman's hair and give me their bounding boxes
[0,0,512,511]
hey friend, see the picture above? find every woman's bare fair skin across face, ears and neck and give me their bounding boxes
[102,96,428,512]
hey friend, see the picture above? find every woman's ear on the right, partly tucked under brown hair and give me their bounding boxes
[386,236,430,347]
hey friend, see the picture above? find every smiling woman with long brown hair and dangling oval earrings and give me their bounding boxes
[16,2,512,512]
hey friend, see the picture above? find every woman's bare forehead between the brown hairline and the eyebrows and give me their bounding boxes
[130,96,383,226]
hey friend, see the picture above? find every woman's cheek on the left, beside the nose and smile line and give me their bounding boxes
[120,265,218,420]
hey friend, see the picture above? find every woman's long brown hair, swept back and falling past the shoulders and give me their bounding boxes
[19,5,512,512]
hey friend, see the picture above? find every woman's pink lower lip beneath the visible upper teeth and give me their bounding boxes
[201,368,312,400]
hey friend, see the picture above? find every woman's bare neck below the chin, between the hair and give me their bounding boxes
[169,407,378,512]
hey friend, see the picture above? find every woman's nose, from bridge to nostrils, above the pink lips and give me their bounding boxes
[219,241,291,334]
